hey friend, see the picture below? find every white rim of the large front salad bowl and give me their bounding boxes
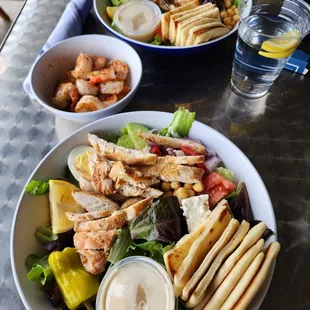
[10,111,277,310]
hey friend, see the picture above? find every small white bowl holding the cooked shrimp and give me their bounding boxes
[30,35,142,123]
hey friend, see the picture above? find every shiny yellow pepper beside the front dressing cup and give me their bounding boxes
[48,248,99,309]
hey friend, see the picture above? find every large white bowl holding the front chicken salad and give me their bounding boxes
[11,112,276,310]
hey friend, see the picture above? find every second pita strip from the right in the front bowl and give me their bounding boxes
[220,252,265,310]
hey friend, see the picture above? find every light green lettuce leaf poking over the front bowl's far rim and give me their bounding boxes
[159,107,196,137]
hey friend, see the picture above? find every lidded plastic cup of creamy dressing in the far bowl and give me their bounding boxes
[114,0,161,42]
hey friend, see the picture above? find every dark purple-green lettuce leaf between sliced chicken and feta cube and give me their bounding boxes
[129,196,182,243]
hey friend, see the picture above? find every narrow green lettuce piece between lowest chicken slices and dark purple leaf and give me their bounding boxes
[108,226,132,264]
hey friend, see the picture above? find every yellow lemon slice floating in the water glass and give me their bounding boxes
[258,30,300,58]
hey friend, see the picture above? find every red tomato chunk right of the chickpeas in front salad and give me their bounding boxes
[202,172,236,209]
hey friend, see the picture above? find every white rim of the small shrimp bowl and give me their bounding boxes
[30,34,143,117]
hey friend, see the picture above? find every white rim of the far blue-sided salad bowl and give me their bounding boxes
[94,0,239,50]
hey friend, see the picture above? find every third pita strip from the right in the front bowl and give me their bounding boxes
[203,239,265,310]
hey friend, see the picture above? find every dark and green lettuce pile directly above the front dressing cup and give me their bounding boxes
[108,196,185,264]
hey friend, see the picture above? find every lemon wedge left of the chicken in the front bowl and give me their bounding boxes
[49,180,85,234]
